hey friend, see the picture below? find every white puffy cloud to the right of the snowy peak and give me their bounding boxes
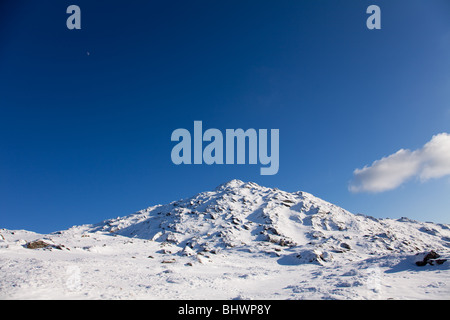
[349,133,450,192]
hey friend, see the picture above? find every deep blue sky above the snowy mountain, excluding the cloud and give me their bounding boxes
[0,0,450,232]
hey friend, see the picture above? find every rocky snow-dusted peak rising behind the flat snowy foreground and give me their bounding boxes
[68,180,450,259]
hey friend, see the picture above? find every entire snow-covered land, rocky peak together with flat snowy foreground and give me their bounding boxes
[0,180,450,299]
